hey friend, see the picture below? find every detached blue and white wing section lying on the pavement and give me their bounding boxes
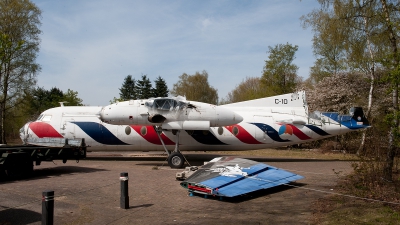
[181,157,304,197]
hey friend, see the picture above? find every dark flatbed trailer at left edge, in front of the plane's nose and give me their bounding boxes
[0,138,87,178]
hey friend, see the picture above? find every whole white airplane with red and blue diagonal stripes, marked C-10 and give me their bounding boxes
[20,91,369,168]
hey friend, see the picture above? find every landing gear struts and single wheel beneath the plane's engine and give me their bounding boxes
[153,126,186,169]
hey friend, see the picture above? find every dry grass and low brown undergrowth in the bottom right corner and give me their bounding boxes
[312,160,400,224]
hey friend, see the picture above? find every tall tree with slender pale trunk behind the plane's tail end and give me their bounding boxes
[302,0,381,154]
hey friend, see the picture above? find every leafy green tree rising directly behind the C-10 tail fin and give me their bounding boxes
[261,43,300,95]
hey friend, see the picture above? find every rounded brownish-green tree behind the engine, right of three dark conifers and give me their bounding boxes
[171,70,218,104]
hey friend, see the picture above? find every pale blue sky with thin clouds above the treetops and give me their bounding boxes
[31,0,319,106]
